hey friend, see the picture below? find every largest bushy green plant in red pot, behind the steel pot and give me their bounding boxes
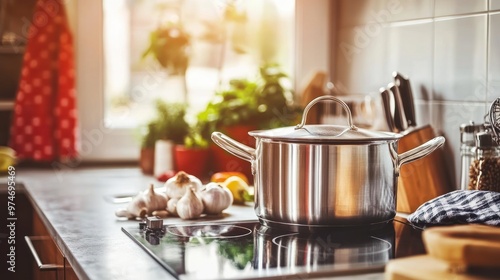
[197,64,301,178]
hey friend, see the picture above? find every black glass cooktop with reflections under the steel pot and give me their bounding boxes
[122,217,425,279]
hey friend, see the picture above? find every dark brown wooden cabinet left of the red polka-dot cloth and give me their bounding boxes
[0,0,35,146]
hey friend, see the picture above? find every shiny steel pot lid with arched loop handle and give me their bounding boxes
[249,95,403,144]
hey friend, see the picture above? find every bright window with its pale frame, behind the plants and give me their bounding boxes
[75,0,329,160]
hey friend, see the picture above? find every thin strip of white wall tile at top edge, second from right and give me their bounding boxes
[434,0,488,17]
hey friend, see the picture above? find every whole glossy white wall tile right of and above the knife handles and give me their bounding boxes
[433,15,487,101]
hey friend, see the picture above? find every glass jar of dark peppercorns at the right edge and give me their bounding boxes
[468,132,500,192]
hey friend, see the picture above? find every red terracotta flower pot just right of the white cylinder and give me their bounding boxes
[174,145,210,179]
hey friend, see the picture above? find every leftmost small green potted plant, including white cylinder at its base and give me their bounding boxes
[140,100,189,176]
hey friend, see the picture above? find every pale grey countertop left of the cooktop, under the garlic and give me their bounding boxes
[16,168,257,279]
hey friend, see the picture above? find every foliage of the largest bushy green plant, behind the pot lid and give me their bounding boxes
[197,64,302,139]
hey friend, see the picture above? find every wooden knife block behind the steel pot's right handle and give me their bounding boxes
[396,125,454,213]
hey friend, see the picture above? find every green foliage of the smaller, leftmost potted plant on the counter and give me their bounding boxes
[141,100,189,148]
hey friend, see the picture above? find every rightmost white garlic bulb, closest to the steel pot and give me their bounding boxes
[199,183,233,215]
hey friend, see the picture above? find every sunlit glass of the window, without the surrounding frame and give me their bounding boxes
[103,0,295,128]
